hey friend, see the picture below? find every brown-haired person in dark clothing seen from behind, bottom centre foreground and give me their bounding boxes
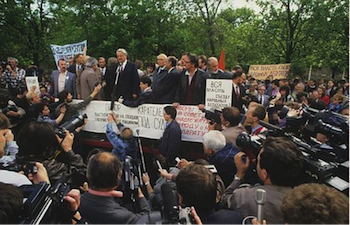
[176,164,243,225]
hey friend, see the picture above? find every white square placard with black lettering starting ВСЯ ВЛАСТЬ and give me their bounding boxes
[205,79,232,110]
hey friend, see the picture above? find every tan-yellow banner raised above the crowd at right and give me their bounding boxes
[248,63,290,80]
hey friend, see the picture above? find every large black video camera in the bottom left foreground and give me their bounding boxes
[18,181,72,225]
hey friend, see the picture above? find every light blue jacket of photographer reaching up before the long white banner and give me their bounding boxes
[106,123,137,162]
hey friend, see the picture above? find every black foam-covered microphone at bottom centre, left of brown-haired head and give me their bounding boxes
[161,183,180,223]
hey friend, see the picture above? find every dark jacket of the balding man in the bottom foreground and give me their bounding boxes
[79,193,150,225]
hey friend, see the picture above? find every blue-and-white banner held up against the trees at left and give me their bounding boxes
[51,40,87,67]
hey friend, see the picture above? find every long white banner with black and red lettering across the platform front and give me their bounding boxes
[79,100,208,142]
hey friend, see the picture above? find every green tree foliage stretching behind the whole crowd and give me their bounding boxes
[0,0,349,77]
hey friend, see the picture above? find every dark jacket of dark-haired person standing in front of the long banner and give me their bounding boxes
[159,120,181,165]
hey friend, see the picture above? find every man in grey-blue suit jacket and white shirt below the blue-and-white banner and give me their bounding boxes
[52,59,77,98]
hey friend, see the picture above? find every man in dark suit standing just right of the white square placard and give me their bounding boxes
[232,70,245,113]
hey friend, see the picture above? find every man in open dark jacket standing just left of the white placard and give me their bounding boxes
[173,53,208,109]
